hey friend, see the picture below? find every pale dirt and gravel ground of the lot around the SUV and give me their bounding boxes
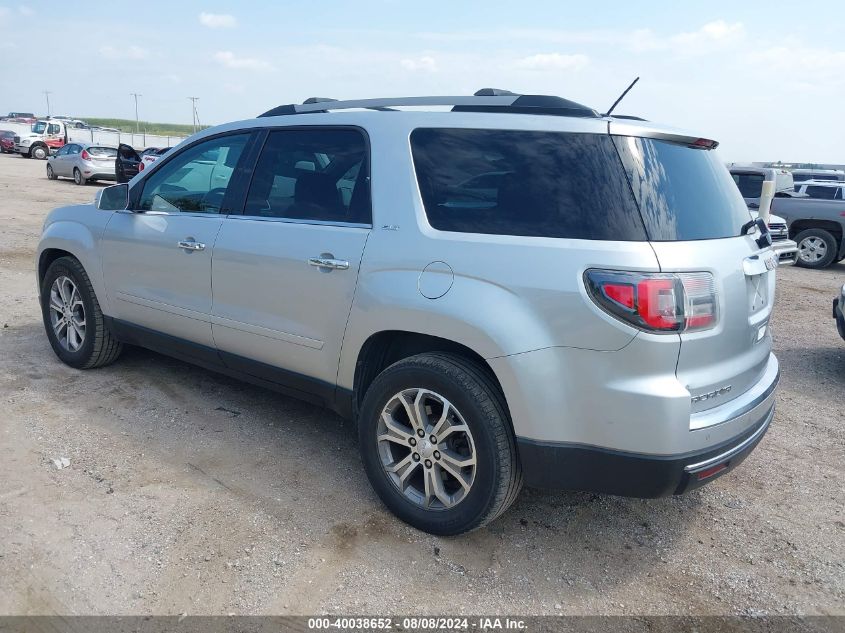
[0,155,845,615]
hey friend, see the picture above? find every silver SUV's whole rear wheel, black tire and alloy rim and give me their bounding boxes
[358,353,522,536]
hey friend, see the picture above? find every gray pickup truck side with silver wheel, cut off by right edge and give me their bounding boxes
[772,193,845,268]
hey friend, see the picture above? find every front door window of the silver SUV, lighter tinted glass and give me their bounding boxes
[138,134,249,213]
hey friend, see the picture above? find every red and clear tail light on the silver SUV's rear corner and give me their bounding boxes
[584,269,718,332]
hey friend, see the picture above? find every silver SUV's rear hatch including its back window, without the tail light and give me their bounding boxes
[610,130,777,413]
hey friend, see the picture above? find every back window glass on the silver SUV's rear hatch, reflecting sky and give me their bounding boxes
[614,136,751,242]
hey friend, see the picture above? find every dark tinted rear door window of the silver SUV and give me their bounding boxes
[244,128,371,224]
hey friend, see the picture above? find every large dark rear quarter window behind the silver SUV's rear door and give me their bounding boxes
[411,128,646,241]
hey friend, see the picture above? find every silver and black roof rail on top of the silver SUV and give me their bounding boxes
[259,88,600,118]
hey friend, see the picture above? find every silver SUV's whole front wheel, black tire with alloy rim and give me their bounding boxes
[41,257,123,369]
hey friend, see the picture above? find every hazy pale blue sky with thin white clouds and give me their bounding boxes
[0,0,845,163]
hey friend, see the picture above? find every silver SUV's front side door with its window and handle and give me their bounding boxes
[101,132,250,359]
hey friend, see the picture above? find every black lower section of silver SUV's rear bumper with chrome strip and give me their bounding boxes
[517,403,775,498]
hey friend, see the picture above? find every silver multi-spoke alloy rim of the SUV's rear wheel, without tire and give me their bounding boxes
[376,388,476,510]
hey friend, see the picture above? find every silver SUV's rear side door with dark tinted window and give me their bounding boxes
[212,127,371,398]
